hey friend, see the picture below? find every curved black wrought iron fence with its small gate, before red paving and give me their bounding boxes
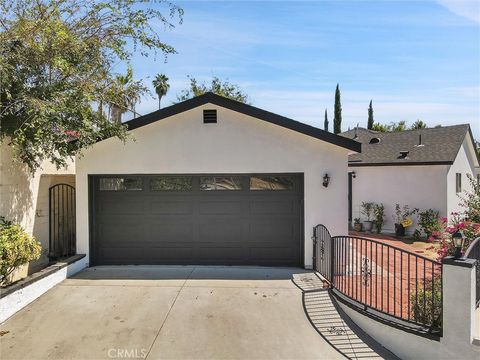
[314,225,443,333]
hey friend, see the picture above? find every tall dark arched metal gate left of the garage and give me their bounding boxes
[48,184,76,259]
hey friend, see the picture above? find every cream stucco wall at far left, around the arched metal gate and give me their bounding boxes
[0,139,75,278]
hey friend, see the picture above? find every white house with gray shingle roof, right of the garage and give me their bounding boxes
[341,124,479,232]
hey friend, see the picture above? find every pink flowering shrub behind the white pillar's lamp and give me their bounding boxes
[428,212,480,261]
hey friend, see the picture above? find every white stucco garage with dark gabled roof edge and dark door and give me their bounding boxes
[76,93,361,267]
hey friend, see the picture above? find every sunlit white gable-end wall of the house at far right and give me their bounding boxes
[447,136,478,215]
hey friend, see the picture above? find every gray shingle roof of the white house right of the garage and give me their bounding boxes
[340,124,475,166]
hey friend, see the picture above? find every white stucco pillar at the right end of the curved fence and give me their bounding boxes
[442,257,476,354]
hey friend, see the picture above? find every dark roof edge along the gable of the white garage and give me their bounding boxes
[124,92,361,152]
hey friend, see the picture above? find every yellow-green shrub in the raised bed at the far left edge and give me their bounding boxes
[0,219,42,285]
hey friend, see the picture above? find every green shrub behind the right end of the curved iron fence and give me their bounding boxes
[410,276,442,328]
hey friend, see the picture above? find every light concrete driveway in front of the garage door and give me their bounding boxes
[0,266,343,360]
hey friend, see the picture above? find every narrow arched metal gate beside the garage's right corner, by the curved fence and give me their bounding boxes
[312,225,333,282]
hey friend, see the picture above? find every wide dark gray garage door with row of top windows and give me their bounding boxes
[91,174,303,266]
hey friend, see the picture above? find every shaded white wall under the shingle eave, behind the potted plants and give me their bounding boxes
[349,165,447,232]
